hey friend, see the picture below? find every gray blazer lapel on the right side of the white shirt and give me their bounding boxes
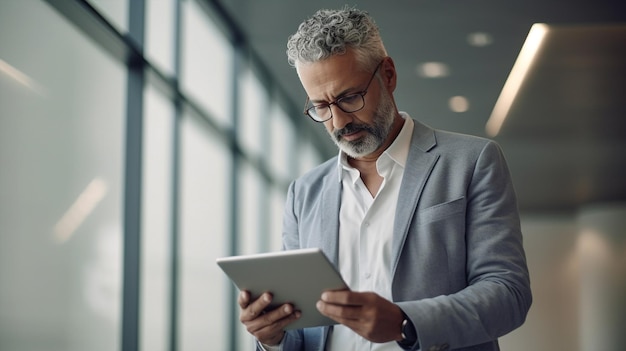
[392,120,439,274]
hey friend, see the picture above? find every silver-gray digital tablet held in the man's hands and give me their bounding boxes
[217,248,348,329]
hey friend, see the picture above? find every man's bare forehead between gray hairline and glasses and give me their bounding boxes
[297,52,367,101]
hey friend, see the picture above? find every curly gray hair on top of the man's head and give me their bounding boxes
[287,7,387,68]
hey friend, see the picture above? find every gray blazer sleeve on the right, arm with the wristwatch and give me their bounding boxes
[398,141,532,349]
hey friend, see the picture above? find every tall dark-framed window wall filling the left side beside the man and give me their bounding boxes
[0,0,330,351]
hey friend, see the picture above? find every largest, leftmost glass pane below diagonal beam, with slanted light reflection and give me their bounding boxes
[0,0,126,351]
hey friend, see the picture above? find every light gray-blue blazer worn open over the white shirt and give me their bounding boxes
[266,121,532,351]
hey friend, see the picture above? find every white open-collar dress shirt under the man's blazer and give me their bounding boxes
[263,112,414,351]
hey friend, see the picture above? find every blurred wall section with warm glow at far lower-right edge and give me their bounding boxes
[578,204,626,351]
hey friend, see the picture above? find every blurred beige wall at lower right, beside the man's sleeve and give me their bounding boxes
[501,204,626,351]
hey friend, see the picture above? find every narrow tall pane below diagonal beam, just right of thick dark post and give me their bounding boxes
[140,86,174,351]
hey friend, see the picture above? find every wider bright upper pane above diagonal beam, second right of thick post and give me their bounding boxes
[181,1,234,126]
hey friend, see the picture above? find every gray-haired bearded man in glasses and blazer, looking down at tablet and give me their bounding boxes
[239,8,532,351]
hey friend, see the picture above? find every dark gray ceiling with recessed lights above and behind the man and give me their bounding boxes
[216,0,626,212]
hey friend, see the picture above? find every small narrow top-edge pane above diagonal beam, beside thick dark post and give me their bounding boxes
[146,0,176,75]
